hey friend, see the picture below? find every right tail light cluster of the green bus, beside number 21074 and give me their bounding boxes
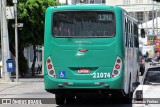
[112,57,122,78]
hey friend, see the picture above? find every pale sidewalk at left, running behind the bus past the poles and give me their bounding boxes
[0,73,43,92]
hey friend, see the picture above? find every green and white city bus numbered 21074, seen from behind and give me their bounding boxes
[44,4,142,104]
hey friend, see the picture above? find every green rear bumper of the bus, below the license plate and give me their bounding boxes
[44,75,123,90]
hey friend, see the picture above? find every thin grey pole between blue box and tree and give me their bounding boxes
[13,0,18,82]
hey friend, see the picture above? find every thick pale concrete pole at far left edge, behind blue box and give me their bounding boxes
[1,0,11,81]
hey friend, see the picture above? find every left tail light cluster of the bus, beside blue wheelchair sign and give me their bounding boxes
[46,56,56,78]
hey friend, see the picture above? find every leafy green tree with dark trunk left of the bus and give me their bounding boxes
[8,0,59,77]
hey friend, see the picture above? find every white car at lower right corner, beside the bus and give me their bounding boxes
[132,65,160,107]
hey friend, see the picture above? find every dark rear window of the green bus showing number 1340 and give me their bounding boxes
[52,11,116,37]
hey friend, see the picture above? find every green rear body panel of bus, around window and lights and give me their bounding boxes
[44,5,139,93]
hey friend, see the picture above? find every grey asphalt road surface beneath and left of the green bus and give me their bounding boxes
[0,63,149,107]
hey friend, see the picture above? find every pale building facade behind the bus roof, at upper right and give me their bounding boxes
[59,0,160,23]
